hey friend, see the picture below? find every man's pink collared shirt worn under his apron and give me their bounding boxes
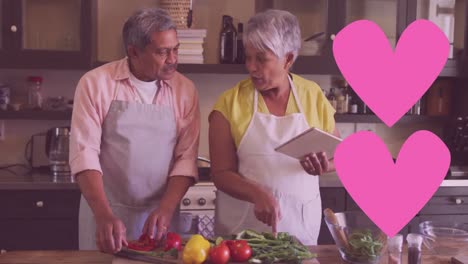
[70,58,200,180]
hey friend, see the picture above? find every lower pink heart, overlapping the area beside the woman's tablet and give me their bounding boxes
[335,130,450,236]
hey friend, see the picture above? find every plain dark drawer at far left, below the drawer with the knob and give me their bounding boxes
[0,218,78,250]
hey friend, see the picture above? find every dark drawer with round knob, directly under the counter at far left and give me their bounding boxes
[0,190,81,219]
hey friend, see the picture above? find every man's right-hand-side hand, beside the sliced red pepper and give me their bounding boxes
[142,207,174,240]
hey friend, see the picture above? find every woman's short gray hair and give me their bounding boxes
[243,9,301,61]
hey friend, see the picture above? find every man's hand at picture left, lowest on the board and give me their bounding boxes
[96,212,128,254]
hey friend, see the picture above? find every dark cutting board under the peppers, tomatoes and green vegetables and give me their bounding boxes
[112,251,320,264]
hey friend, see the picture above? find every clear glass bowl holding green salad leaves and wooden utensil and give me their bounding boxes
[325,211,387,264]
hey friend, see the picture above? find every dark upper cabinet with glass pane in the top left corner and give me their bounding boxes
[0,0,92,69]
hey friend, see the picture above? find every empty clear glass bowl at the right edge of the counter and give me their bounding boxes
[419,221,468,256]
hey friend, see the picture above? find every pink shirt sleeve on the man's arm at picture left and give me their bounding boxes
[70,75,102,175]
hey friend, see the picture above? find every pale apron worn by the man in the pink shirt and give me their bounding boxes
[79,80,179,250]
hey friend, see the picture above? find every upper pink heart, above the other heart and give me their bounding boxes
[333,20,450,127]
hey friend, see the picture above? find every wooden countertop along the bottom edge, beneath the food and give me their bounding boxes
[0,245,460,264]
